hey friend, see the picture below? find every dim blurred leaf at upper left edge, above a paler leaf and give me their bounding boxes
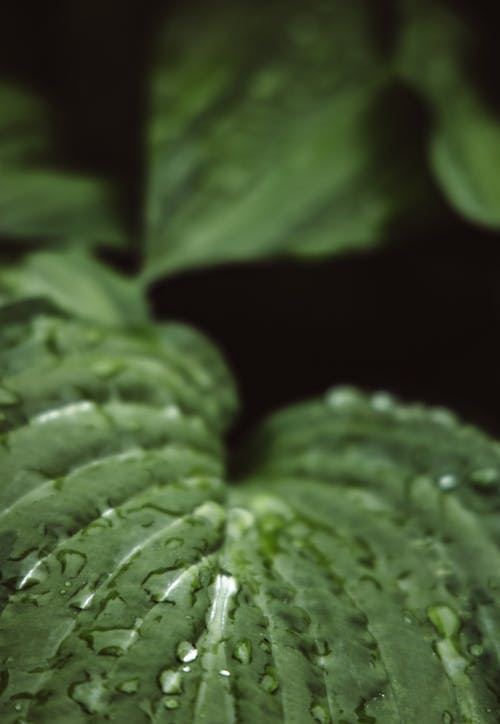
[0,83,123,244]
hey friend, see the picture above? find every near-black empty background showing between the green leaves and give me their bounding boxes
[0,0,500,437]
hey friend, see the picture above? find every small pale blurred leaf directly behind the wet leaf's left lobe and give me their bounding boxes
[0,246,148,326]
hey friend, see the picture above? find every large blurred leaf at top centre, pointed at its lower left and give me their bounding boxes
[144,2,420,279]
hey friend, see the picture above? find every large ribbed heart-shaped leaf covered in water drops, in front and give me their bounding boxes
[0,301,500,724]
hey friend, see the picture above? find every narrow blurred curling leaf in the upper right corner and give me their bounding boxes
[398,0,500,228]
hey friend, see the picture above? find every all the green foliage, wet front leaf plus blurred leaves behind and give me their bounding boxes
[0,0,500,724]
